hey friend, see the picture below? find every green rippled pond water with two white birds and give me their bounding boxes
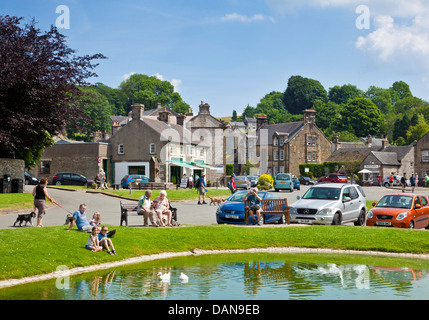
[0,253,429,300]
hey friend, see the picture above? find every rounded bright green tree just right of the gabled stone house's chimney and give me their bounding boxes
[341,98,383,136]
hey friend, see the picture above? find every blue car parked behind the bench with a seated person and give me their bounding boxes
[216,191,285,224]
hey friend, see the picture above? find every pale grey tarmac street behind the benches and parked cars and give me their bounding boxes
[0,186,428,229]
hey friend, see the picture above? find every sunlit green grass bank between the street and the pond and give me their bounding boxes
[0,225,429,280]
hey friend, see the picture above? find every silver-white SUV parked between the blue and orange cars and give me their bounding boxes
[290,183,366,226]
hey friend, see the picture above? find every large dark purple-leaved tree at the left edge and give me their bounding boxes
[0,15,105,167]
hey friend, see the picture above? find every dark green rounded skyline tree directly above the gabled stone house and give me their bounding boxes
[283,76,328,114]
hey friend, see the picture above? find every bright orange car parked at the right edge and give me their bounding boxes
[366,193,429,229]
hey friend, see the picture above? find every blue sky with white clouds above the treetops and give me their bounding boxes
[0,0,429,116]
